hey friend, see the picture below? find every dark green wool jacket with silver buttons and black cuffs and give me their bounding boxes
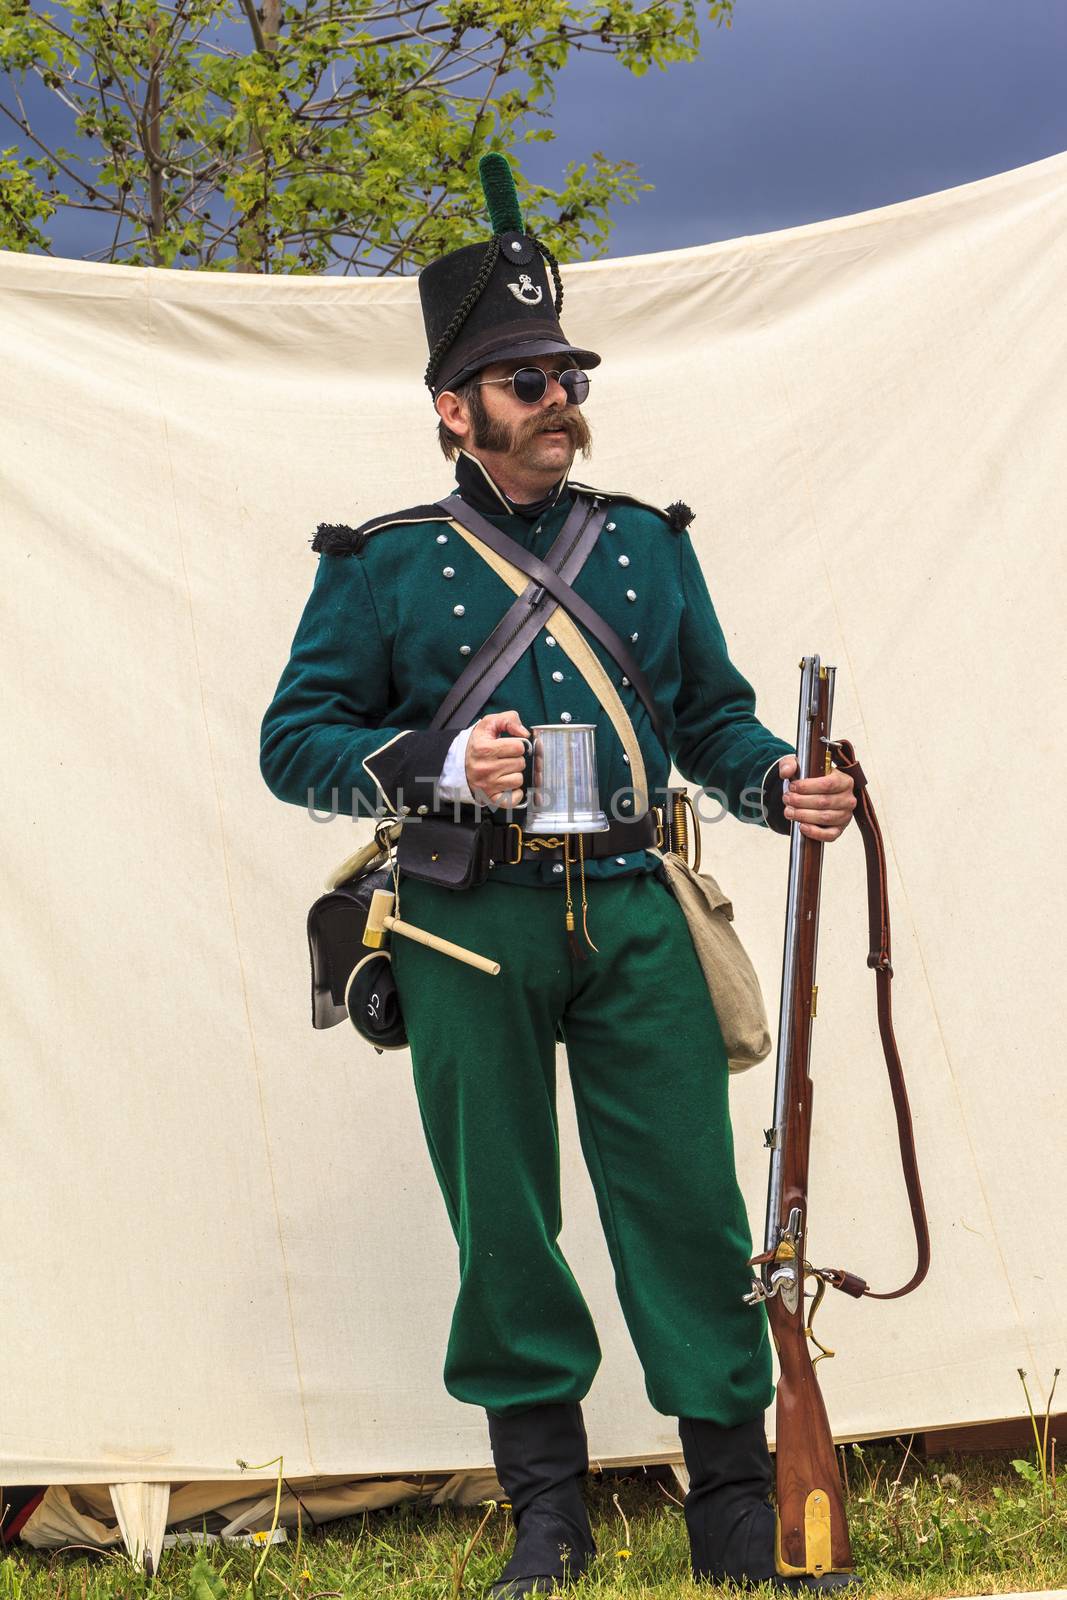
[261,456,792,886]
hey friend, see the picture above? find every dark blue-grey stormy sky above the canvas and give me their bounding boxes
[3,0,1067,256]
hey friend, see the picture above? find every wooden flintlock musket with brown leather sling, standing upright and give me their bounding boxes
[745,656,929,1576]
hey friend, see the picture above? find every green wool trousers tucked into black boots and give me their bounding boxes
[392,874,774,1427]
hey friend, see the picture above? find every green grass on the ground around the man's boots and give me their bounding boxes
[0,1438,1067,1600]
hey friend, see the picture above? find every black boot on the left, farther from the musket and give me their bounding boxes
[486,1405,597,1600]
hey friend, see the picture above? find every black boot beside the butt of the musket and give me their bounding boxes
[678,1416,859,1594]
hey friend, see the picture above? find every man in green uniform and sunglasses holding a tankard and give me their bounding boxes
[262,152,854,1600]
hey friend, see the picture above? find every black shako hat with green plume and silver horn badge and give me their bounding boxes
[419,152,600,395]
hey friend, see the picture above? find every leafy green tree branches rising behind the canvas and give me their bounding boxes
[0,0,733,274]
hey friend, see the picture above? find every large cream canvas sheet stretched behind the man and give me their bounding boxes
[0,155,1067,1561]
